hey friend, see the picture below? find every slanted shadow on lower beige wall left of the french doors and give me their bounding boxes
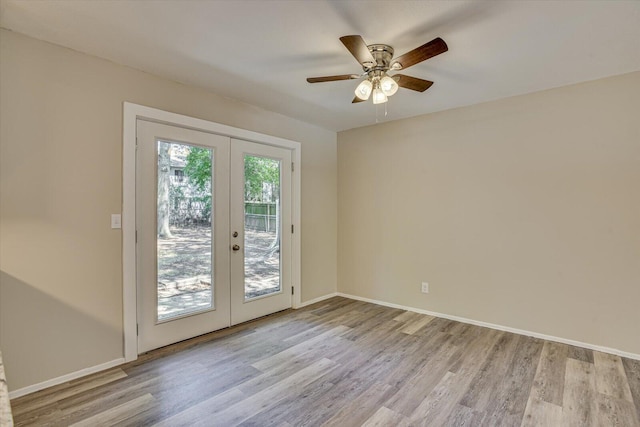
[0,271,123,391]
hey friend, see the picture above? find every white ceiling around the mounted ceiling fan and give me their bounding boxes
[0,0,640,131]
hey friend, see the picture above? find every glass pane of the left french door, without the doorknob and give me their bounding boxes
[157,141,214,321]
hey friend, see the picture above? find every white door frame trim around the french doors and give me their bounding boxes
[122,102,302,362]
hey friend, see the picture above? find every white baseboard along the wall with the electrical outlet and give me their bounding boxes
[336,292,640,360]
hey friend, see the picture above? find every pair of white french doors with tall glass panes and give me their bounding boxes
[136,120,291,353]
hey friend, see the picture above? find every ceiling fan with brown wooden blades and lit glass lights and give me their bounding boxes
[307,35,449,104]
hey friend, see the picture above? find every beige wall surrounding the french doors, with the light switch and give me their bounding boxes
[0,30,337,390]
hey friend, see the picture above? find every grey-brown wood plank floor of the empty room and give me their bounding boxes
[12,297,640,427]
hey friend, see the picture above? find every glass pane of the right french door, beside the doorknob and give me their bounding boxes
[244,155,281,301]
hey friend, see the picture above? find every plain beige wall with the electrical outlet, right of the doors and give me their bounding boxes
[338,72,640,354]
